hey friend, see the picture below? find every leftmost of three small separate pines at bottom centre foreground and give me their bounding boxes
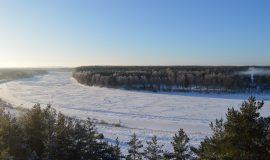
[126,133,143,160]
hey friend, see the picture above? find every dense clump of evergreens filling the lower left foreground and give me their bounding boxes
[0,105,117,160]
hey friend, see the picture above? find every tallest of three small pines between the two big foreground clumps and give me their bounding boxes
[171,129,190,160]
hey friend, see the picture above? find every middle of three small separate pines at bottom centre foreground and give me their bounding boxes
[144,136,164,160]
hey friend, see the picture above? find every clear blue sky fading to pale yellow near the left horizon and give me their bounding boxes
[0,0,270,67]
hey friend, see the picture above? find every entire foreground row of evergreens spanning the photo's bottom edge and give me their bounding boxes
[0,97,270,160]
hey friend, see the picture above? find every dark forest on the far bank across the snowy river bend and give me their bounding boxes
[73,66,270,92]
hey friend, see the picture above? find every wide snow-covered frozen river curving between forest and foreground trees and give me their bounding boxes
[0,71,270,149]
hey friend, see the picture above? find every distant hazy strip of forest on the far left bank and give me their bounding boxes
[0,69,47,80]
